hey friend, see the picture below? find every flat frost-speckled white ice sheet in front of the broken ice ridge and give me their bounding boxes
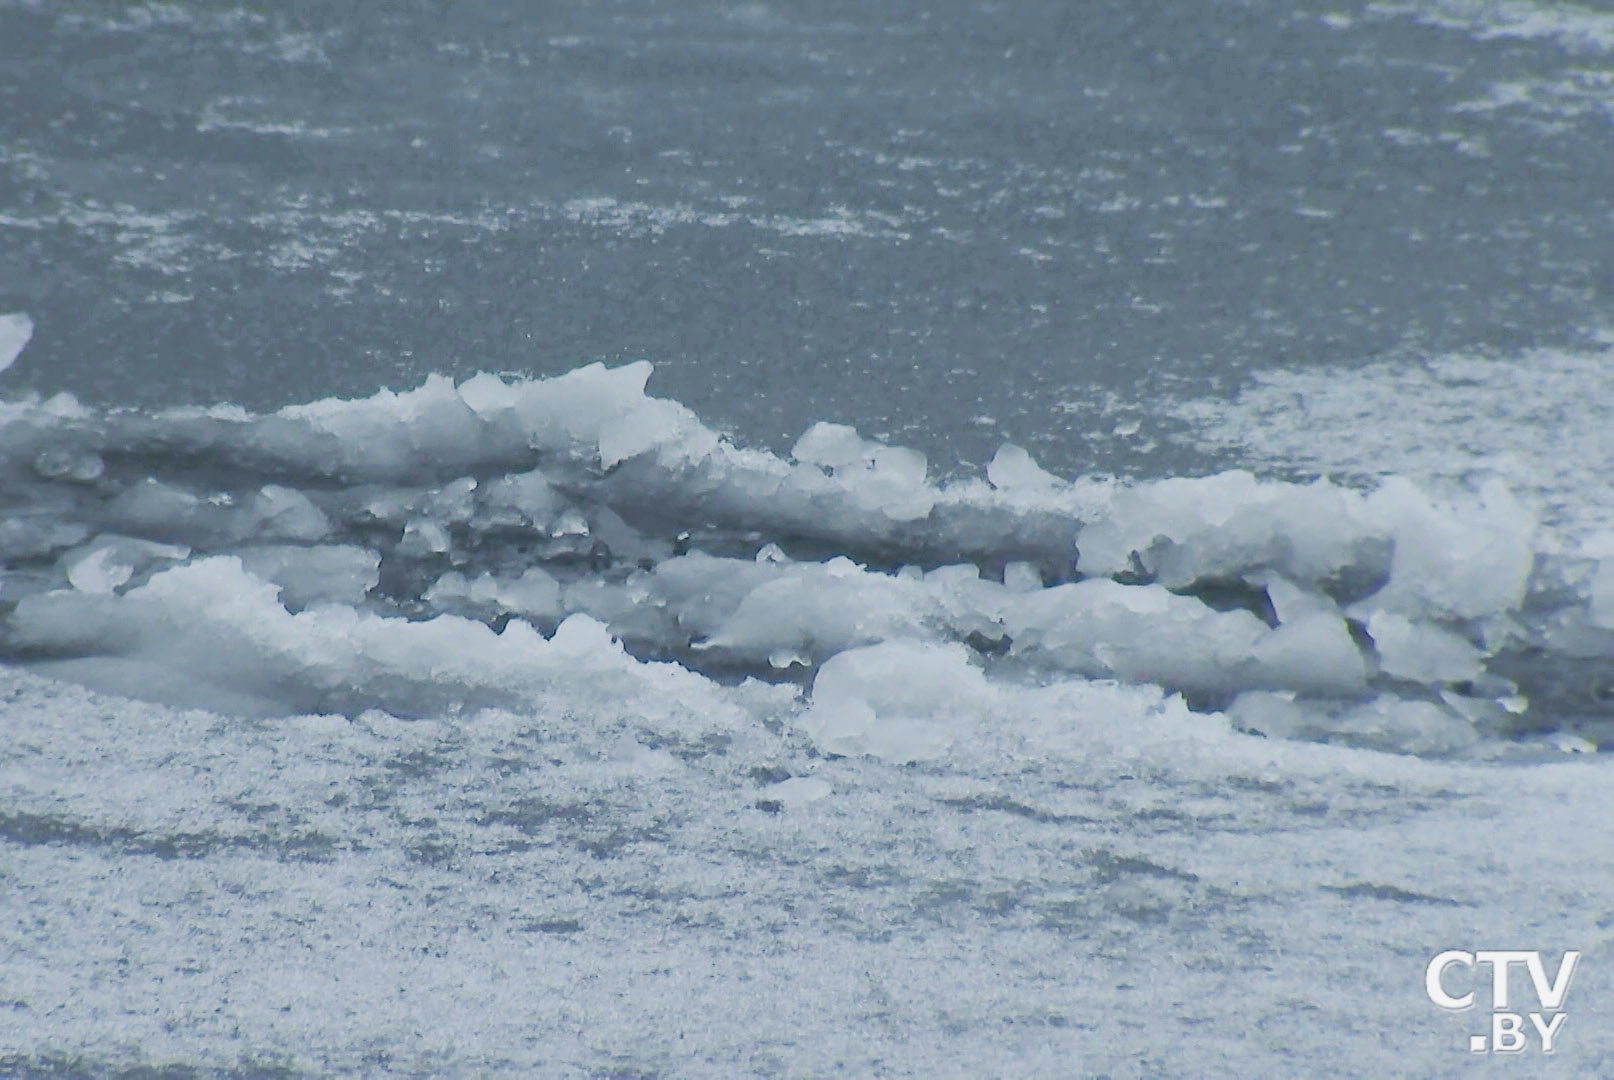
[0,661,1614,1077]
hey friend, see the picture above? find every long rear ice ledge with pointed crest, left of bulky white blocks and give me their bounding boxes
[0,362,1088,563]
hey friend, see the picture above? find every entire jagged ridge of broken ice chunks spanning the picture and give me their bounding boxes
[0,363,1614,754]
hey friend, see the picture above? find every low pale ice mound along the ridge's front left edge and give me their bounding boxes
[8,555,748,717]
